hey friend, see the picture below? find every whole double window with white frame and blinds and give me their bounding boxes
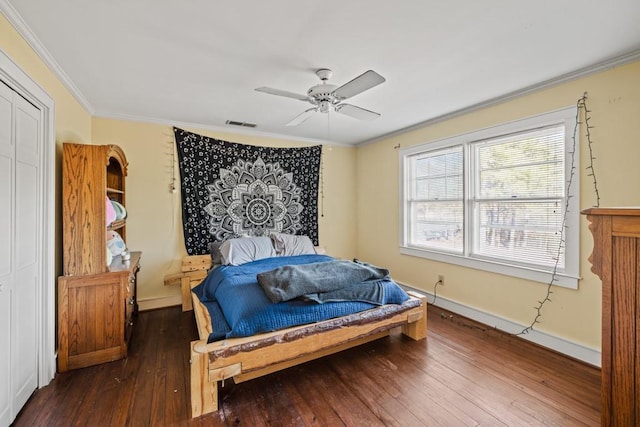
[400,107,579,288]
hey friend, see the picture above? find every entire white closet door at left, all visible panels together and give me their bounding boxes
[0,82,42,426]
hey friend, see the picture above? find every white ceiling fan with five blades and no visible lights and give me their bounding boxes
[256,68,385,126]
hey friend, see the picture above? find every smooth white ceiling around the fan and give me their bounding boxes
[0,0,640,144]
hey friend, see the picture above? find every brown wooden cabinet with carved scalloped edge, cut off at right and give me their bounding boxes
[583,208,640,426]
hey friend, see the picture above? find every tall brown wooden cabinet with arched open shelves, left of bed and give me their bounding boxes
[58,143,141,371]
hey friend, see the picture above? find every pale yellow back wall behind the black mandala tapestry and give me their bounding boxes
[92,118,356,308]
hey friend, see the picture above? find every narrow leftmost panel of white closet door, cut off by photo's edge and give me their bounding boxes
[0,78,15,426]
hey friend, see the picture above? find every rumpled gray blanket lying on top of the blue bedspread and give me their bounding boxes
[257,260,389,303]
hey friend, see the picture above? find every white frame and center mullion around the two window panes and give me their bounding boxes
[398,106,580,289]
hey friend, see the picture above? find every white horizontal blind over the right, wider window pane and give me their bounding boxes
[471,125,565,269]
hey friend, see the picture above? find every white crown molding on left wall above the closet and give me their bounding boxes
[0,0,94,115]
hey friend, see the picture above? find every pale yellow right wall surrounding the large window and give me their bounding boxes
[357,62,640,350]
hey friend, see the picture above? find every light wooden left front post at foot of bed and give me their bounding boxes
[191,340,218,418]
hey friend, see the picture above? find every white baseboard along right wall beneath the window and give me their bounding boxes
[402,285,602,368]
